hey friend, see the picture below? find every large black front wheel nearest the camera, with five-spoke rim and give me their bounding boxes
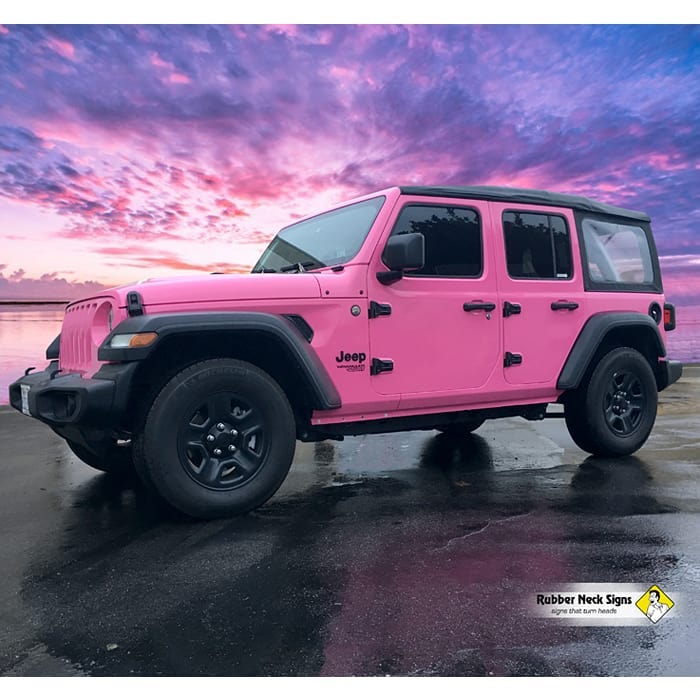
[136,359,296,518]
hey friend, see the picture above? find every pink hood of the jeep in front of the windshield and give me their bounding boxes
[109,273,321,306]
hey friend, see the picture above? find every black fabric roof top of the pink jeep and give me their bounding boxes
[399,185,651,221]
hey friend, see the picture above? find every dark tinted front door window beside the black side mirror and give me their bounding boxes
[391,204,483,277]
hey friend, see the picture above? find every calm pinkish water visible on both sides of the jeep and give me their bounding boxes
[0,304,700,404]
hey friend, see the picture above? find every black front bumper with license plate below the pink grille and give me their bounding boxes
[10,361,137,428]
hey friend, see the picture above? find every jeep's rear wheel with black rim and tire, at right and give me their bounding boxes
[564,348,658,457]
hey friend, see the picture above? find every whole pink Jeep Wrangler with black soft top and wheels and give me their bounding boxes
[10,187,682,518]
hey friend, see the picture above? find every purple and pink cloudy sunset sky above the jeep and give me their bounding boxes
[0,25,700,318]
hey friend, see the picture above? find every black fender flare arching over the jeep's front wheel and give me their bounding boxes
[97,311,342,410]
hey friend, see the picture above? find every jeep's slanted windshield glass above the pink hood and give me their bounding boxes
[252,197,385,272]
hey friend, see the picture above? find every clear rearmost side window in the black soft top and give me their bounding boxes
[582,219,654,285]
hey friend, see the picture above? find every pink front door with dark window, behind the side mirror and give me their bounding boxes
[368,197,501,408]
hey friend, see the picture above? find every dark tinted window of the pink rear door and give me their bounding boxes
[503,211,571,279]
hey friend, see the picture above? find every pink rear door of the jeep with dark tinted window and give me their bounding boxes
[491,202,586,385]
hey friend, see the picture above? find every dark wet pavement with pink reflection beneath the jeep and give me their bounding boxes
[0,368,700,676]
